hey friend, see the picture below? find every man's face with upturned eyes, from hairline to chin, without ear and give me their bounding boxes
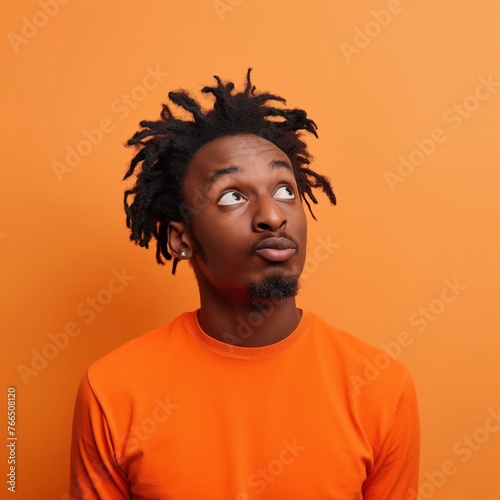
[178,134,307,298]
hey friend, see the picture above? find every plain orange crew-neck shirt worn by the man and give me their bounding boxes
[70,312,419,500]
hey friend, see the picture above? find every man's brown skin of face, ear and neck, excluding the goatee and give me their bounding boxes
[168,134,307,347]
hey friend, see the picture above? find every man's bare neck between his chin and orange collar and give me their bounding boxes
[198,290,302,347]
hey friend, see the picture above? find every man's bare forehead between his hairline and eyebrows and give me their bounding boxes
[188,134,291,178]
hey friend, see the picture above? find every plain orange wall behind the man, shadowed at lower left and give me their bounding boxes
[0,0,500,500]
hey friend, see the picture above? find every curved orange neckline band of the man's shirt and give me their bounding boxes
[189,310,311,359]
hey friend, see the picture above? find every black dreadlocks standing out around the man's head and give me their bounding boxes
[124,68,336,274]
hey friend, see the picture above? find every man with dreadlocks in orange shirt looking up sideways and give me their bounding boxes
[71,70,419,500]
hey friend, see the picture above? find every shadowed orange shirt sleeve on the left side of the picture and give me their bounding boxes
[70,373,131,500]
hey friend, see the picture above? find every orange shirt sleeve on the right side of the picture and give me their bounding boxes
[363,372,420,500]
